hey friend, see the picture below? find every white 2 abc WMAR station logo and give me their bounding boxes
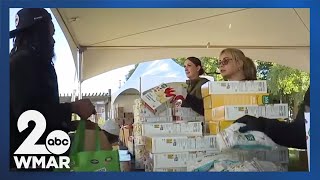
[13,110,71,169]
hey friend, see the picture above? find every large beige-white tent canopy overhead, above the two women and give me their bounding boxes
[51,8,310,82]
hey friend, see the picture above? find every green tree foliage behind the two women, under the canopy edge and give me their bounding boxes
[126,57,310,119]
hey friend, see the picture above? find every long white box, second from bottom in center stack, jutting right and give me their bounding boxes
[146,135,219,153]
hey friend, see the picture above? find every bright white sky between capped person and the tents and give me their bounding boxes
[9,8,134,93]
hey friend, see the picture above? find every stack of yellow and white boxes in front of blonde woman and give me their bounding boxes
[202,81,289,169]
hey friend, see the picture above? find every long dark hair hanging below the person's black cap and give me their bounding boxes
[10,21,54,61]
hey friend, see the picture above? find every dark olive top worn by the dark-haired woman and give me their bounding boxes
[181,78,209,116]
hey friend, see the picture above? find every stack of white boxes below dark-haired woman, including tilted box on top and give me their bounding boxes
[130,83,218,172]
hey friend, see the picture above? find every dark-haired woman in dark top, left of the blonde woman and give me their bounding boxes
[181,57,209,115]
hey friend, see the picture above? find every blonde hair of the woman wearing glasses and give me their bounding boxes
[220,48,257,80]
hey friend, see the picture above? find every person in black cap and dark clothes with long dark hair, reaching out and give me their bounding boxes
[10,8,95,169]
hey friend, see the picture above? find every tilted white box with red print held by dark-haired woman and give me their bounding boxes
[141,82,187,113]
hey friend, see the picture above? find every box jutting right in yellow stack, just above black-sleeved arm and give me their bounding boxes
[205,104,289,121]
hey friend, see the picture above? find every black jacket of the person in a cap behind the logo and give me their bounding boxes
[10,49,71,168]
